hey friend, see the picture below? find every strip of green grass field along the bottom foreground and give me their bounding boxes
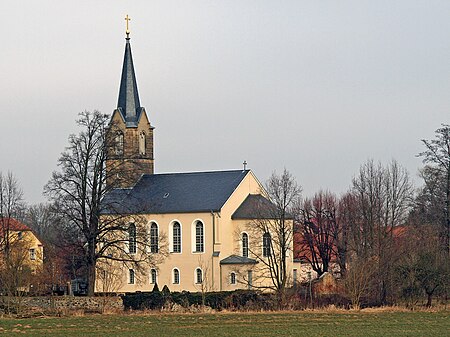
[0,311,450,337]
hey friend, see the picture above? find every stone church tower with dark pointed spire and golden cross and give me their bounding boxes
[106,15,154,188]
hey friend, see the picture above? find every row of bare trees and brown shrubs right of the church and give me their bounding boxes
[296,125,450,306]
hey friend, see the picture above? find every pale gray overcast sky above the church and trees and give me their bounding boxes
[0,0,450,203]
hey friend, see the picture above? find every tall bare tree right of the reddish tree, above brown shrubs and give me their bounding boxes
[349,160,413,303]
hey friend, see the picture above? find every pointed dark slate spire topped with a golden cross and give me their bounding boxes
[117,15,142,125]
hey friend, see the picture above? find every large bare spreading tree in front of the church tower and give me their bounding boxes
[44,111,165,295]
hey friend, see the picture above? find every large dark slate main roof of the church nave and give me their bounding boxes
[102,170,249,214]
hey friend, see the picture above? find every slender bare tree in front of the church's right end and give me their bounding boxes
[243,169,301,305]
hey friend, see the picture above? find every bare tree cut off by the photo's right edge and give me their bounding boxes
[419,124,450,255]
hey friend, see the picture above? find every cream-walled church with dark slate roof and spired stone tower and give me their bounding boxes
[96,22,296,293]
